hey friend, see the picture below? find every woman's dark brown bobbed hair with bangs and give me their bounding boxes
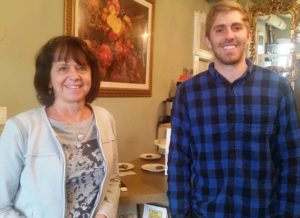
[34,36,100,106]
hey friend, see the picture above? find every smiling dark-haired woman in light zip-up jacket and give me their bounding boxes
[0,36,120,218]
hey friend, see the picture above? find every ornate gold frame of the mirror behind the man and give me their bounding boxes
[249,0,299,87]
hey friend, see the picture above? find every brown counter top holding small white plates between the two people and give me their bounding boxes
[119,157,168,206]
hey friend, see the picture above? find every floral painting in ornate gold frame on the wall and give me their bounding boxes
[64,0,155,96]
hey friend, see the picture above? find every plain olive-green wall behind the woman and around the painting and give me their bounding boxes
[0,0,209,161]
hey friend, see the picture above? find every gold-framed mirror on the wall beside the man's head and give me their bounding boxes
[249,0,299,87]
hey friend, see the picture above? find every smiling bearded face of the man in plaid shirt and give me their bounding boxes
[206,11,250,65]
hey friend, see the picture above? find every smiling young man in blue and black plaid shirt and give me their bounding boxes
[168,0,300,218]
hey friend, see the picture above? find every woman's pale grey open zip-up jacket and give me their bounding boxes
[0,106,120,218]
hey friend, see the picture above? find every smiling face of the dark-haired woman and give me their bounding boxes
[49,58,92,103]
